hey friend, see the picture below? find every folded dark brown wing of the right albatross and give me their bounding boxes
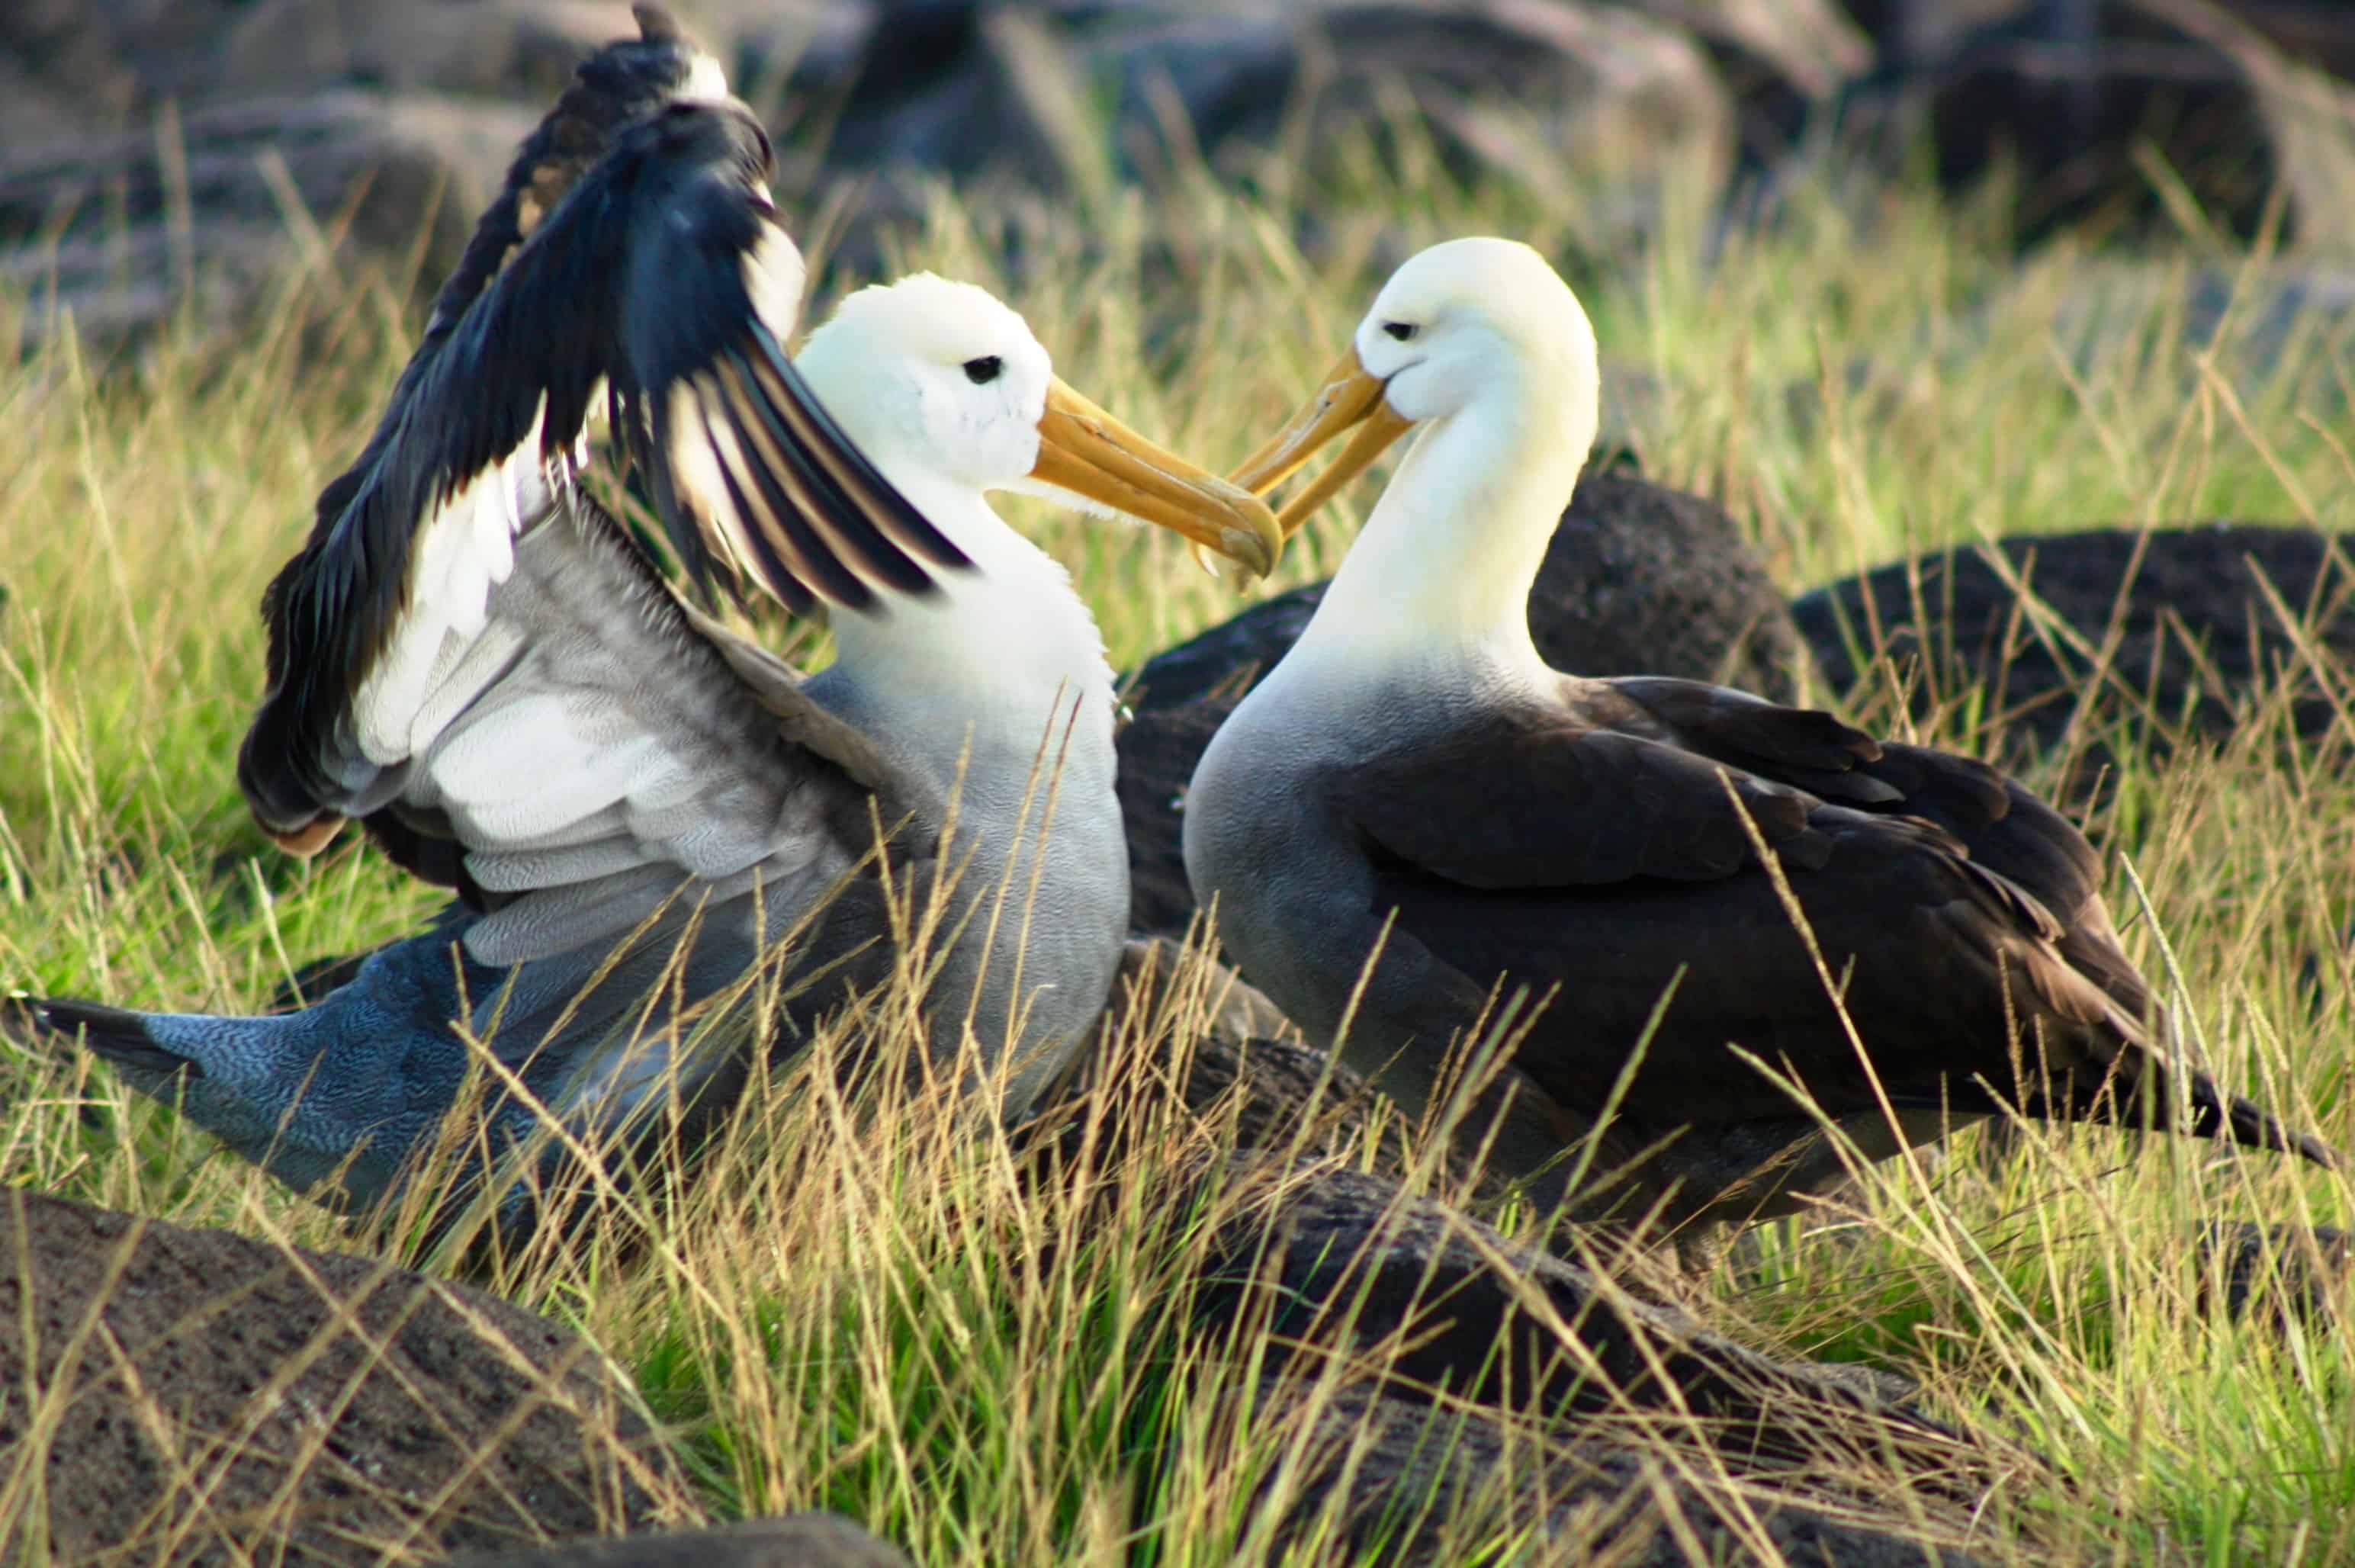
[1333,678,2334,1163]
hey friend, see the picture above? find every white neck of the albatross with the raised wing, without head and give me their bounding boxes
[812,474,1114,777]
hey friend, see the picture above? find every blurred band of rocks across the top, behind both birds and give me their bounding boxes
[14,0,2355,355]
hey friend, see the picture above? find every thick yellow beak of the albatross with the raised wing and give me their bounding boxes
[1029,377,1284,577]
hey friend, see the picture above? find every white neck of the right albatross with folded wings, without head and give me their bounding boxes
[1284,365,1595,687]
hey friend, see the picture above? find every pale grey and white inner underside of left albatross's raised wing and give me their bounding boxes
[334,492,904,968]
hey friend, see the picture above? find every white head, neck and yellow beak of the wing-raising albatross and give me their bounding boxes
[794,275,1284,767]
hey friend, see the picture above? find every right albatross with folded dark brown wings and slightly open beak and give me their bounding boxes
[1184,240,2336,1241]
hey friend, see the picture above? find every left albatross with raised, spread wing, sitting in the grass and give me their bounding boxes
[37,9,1281,1206]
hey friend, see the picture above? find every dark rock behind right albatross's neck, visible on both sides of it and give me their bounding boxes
[1119,474,1804,935]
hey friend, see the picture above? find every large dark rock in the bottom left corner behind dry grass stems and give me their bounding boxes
[0,1191,695,1563]
